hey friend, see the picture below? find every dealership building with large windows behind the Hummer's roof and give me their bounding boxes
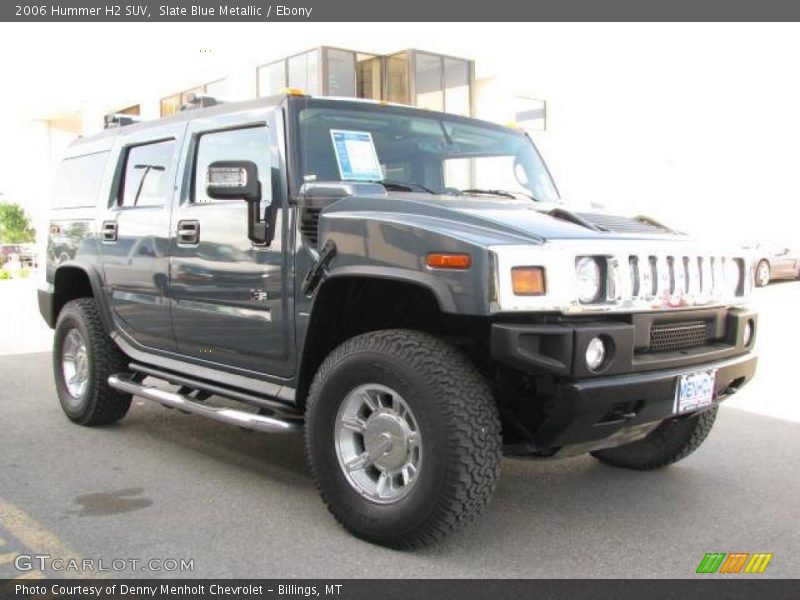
[39,46,546,138]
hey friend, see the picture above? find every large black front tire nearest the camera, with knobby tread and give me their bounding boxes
[306,330,502,549]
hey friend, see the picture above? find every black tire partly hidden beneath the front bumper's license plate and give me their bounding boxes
[591,407,717,471]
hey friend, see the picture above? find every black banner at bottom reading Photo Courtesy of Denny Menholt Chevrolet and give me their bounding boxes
[0,576,800,600]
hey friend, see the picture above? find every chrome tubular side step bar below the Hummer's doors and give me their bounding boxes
[108,375,303,433]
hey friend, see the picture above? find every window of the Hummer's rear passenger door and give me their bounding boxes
[118,140,175,206]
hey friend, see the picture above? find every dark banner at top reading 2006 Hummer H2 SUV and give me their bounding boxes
[0,0,800,23]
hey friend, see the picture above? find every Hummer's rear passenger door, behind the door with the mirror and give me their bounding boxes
[100,122,186,350]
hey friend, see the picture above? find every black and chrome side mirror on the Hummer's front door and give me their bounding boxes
[206,160,269,244]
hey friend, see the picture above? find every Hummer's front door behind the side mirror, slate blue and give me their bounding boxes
[170,108,294,377]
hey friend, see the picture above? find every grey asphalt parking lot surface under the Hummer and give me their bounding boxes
[0,281,800,578]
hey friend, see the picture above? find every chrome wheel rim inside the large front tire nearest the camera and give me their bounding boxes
[334,383,422,504]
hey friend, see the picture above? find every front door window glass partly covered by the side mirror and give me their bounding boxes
[192,125,272,204]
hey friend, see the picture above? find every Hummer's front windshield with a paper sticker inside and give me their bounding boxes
[290,99,559,202]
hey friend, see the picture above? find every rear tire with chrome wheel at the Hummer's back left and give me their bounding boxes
[53,298,131,426]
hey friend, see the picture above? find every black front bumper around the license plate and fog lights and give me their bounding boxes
[491,310,757,456]
